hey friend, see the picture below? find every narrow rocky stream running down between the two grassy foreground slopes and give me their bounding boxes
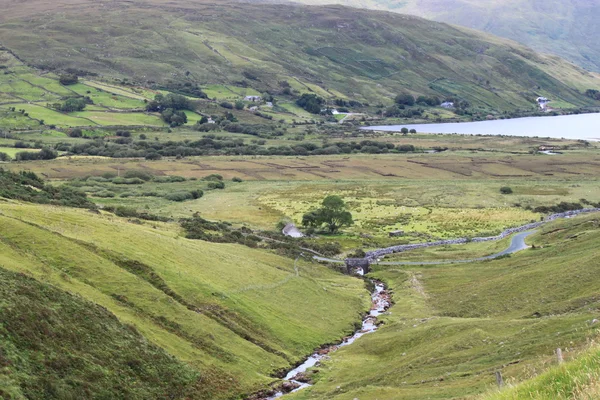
[266,280,391,400]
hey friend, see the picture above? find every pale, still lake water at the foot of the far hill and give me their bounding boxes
[363,114,600,140]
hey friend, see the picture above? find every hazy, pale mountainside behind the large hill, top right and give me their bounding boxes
[298,0,600,71]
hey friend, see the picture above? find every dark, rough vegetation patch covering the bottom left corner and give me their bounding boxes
[0,266,207,399]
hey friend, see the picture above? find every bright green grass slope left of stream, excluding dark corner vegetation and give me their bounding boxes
[0,201,368,399]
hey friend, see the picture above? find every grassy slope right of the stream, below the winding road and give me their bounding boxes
[290,214,600,399]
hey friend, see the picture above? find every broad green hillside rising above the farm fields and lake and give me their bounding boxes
[0,0,600,111]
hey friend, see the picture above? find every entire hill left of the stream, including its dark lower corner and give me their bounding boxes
[0,200,369,399]
